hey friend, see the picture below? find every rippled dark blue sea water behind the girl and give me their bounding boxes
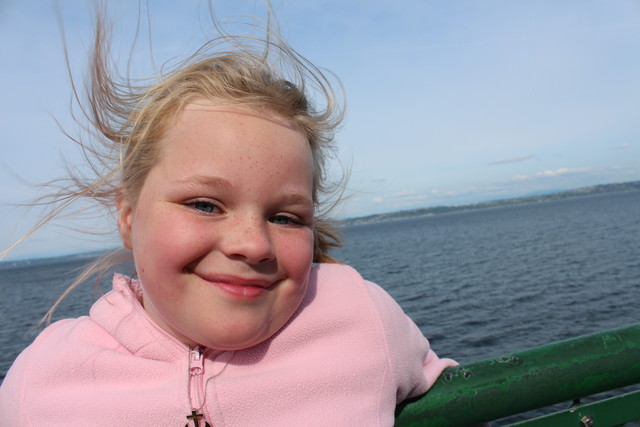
[0,191,640,425]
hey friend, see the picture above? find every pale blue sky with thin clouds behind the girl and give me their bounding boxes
[0,0,640,259]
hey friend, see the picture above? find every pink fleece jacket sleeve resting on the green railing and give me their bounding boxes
[367,282,457,403]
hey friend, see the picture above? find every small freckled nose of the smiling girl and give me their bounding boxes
[220,216,275,264]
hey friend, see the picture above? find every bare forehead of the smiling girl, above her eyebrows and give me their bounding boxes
[158,99,314,186]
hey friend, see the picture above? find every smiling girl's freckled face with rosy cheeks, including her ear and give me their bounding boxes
[118,100,314,350]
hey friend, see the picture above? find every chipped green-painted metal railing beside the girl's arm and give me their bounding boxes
[396,323,640,427]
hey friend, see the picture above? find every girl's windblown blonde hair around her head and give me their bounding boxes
[16,8,344,320]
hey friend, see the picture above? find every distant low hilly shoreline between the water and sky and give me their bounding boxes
[340,181,640,225]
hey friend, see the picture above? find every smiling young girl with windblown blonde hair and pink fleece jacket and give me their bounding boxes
[0,7,454,426]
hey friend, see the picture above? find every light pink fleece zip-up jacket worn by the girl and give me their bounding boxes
[0,264,455,427]
